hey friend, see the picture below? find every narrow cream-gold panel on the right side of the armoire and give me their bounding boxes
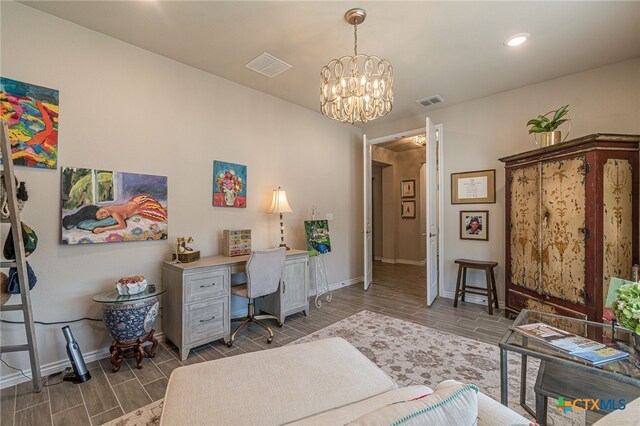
[602,158,633,300]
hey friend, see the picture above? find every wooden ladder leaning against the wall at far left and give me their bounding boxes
[0,120,42,392]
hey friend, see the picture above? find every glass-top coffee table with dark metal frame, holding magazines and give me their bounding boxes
[499,309,640,416]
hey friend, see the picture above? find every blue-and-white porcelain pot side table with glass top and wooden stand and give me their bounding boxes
[93,287,166,373]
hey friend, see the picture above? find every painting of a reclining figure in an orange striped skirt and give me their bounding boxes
[61,167,168,244]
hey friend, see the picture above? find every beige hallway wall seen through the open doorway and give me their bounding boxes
[371,145,425,264]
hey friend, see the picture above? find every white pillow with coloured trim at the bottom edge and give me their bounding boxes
[349,380,479,426]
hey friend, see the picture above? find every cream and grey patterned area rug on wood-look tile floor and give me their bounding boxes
[107,310,585,426]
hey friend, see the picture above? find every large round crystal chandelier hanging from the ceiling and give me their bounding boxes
[320,8,393,124]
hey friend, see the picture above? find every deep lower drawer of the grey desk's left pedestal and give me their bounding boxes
[185,299,228,344]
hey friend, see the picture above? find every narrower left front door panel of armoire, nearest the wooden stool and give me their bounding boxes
[510,164,540,292]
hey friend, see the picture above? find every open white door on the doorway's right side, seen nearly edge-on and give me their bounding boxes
[423,117,440,306]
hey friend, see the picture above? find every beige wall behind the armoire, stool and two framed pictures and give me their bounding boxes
[366,58,640,300]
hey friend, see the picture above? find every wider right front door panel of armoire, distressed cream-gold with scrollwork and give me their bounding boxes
[540,156,588,305]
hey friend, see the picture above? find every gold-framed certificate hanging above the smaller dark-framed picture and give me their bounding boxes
[451,169,496,204]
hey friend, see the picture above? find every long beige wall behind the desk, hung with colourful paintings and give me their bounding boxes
[1,2,362,386]
